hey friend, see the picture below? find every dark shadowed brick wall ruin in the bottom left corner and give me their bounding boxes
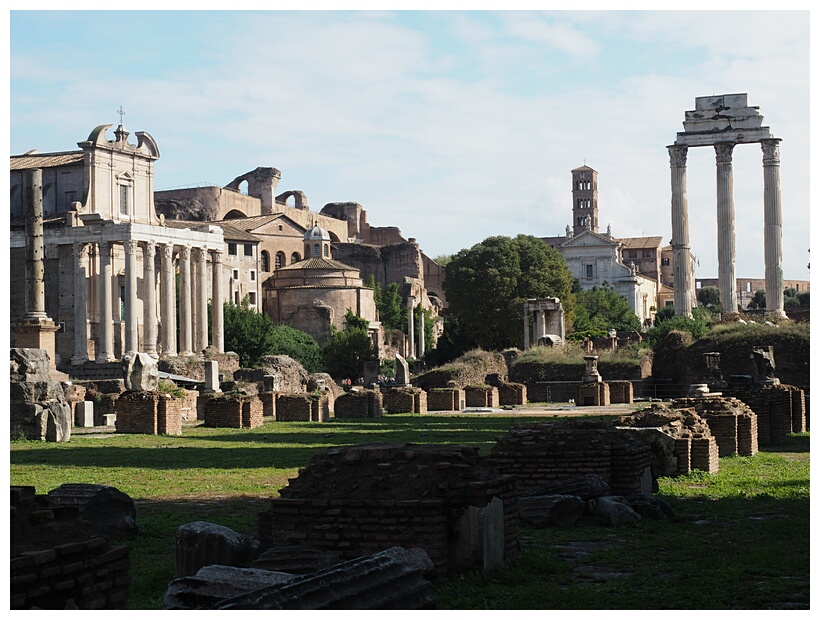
[10,487,131,610]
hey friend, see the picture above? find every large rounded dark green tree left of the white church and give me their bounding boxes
[444,235,575,350]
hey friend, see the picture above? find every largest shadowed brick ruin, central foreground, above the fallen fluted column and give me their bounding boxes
[259,444,518,572]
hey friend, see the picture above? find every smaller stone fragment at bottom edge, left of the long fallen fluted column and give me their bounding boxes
[162,564,296,609]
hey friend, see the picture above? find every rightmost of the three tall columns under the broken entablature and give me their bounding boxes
[760,138,786,318]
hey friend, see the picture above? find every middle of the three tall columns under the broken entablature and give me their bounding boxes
[715,142,737,312]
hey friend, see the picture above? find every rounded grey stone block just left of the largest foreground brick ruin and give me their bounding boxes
[176,521,255,577]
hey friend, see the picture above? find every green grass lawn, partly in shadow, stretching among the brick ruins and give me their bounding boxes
[10,415,810,609]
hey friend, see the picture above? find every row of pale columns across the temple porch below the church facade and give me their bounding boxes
[71,239,225,364]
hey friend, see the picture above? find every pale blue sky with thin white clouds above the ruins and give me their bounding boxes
[8,2,810,280]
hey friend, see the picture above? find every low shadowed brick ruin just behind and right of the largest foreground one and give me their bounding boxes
[489,421,652,495]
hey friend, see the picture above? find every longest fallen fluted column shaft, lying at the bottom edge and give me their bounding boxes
[214,547,435,610]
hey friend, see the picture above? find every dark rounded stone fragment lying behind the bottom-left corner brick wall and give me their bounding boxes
[48,483,139,539]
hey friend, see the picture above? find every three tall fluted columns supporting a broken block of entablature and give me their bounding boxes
[668,138,785,316]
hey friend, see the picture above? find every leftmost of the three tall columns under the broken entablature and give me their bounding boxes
[667,145,695,316]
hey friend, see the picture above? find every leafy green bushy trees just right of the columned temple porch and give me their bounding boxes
[223,297,323,372]
